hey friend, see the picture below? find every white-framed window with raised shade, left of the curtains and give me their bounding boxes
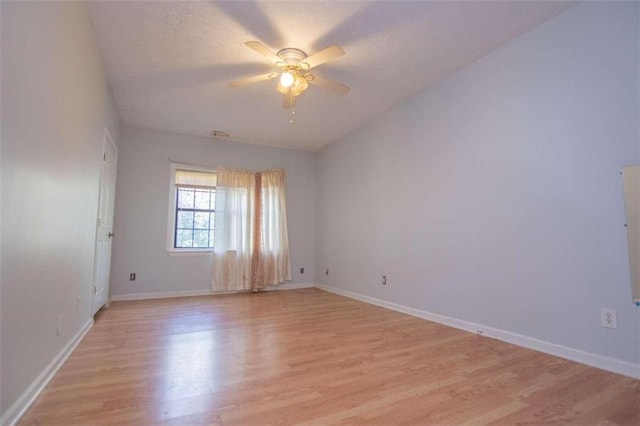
[167,164,216,253]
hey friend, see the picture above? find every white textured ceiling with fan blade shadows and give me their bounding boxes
[89,1,574,150]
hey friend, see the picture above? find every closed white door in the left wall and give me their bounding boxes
[91,129,118,315]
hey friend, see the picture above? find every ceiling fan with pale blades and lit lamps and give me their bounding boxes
[229,41,349,108]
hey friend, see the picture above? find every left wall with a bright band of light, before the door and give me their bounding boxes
[0,2,120,414]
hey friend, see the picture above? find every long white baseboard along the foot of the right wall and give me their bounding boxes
[316,284,640,379]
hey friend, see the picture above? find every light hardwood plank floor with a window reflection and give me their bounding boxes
[21,289,640,425]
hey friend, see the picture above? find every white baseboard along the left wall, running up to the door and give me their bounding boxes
[0,318,93,426]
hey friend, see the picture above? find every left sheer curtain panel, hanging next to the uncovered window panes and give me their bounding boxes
[212,167,256,291]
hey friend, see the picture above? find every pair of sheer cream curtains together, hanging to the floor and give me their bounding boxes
[212,168,291,291]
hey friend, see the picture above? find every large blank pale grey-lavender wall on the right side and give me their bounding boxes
[316,2,640,371]
